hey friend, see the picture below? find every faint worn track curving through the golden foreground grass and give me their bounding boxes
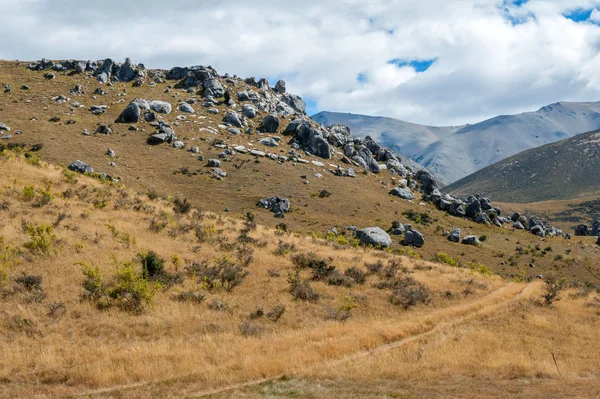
[75,283,532,398]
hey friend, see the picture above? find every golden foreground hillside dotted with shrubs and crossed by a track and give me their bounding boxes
[0,151,600,399]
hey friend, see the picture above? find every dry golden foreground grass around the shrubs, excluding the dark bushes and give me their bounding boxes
[0,153,600,398]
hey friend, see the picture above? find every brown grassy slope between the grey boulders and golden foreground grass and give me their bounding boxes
[0,62,600,284]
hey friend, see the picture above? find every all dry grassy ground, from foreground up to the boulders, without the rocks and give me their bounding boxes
[0,62,600,398]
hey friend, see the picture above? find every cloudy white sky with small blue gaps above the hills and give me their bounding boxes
[0,0,600,125]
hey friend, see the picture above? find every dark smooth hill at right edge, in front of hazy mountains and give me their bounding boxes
[443,130,600,203]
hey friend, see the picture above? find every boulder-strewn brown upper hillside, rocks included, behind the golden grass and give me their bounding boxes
[0,60,596,281]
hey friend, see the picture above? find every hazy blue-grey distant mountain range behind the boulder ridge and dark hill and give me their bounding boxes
[313,102,600,182]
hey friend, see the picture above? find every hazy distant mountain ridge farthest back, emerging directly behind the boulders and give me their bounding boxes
[311,111,462,157]
